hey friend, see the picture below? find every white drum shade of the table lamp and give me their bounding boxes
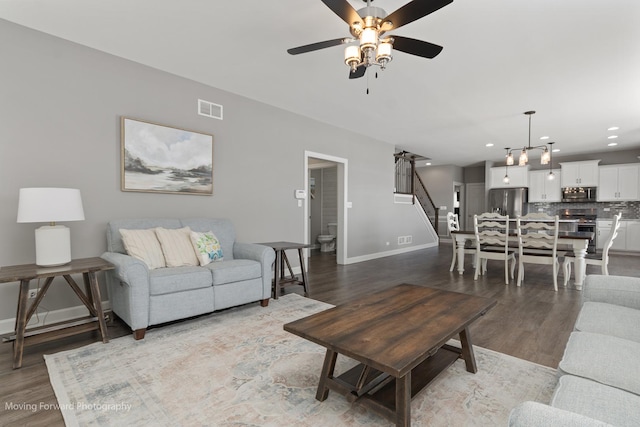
[18,188,84,226]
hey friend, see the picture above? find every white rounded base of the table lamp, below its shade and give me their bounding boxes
[36,225,71,267]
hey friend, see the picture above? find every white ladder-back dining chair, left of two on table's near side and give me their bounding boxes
[473,212,516,285]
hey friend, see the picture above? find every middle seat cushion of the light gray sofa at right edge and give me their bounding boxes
[558,332,640,394]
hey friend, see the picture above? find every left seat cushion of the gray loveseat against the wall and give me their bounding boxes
[149,267,212,295]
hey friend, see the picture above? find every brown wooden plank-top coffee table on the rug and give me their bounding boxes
[284,284,496,426]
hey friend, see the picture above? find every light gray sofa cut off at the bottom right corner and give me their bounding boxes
[509,275,640,427]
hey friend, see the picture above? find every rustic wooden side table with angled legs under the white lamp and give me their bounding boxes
[0,258,115,369]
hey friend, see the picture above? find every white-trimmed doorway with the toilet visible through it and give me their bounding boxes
[304,151,348,264]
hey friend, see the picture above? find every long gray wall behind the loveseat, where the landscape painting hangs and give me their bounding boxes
[0,20,433,321]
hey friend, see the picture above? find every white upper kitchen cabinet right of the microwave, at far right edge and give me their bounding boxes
[598,163,640,202]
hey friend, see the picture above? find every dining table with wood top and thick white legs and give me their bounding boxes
[451,230,595,291]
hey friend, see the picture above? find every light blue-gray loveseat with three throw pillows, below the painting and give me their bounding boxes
[102,219,275,339]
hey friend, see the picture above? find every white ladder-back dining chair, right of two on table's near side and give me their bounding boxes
[516,212,564,292]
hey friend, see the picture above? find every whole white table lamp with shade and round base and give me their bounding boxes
[18,188,84,267]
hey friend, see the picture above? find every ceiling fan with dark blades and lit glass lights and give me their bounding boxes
[287,0,453,79]
